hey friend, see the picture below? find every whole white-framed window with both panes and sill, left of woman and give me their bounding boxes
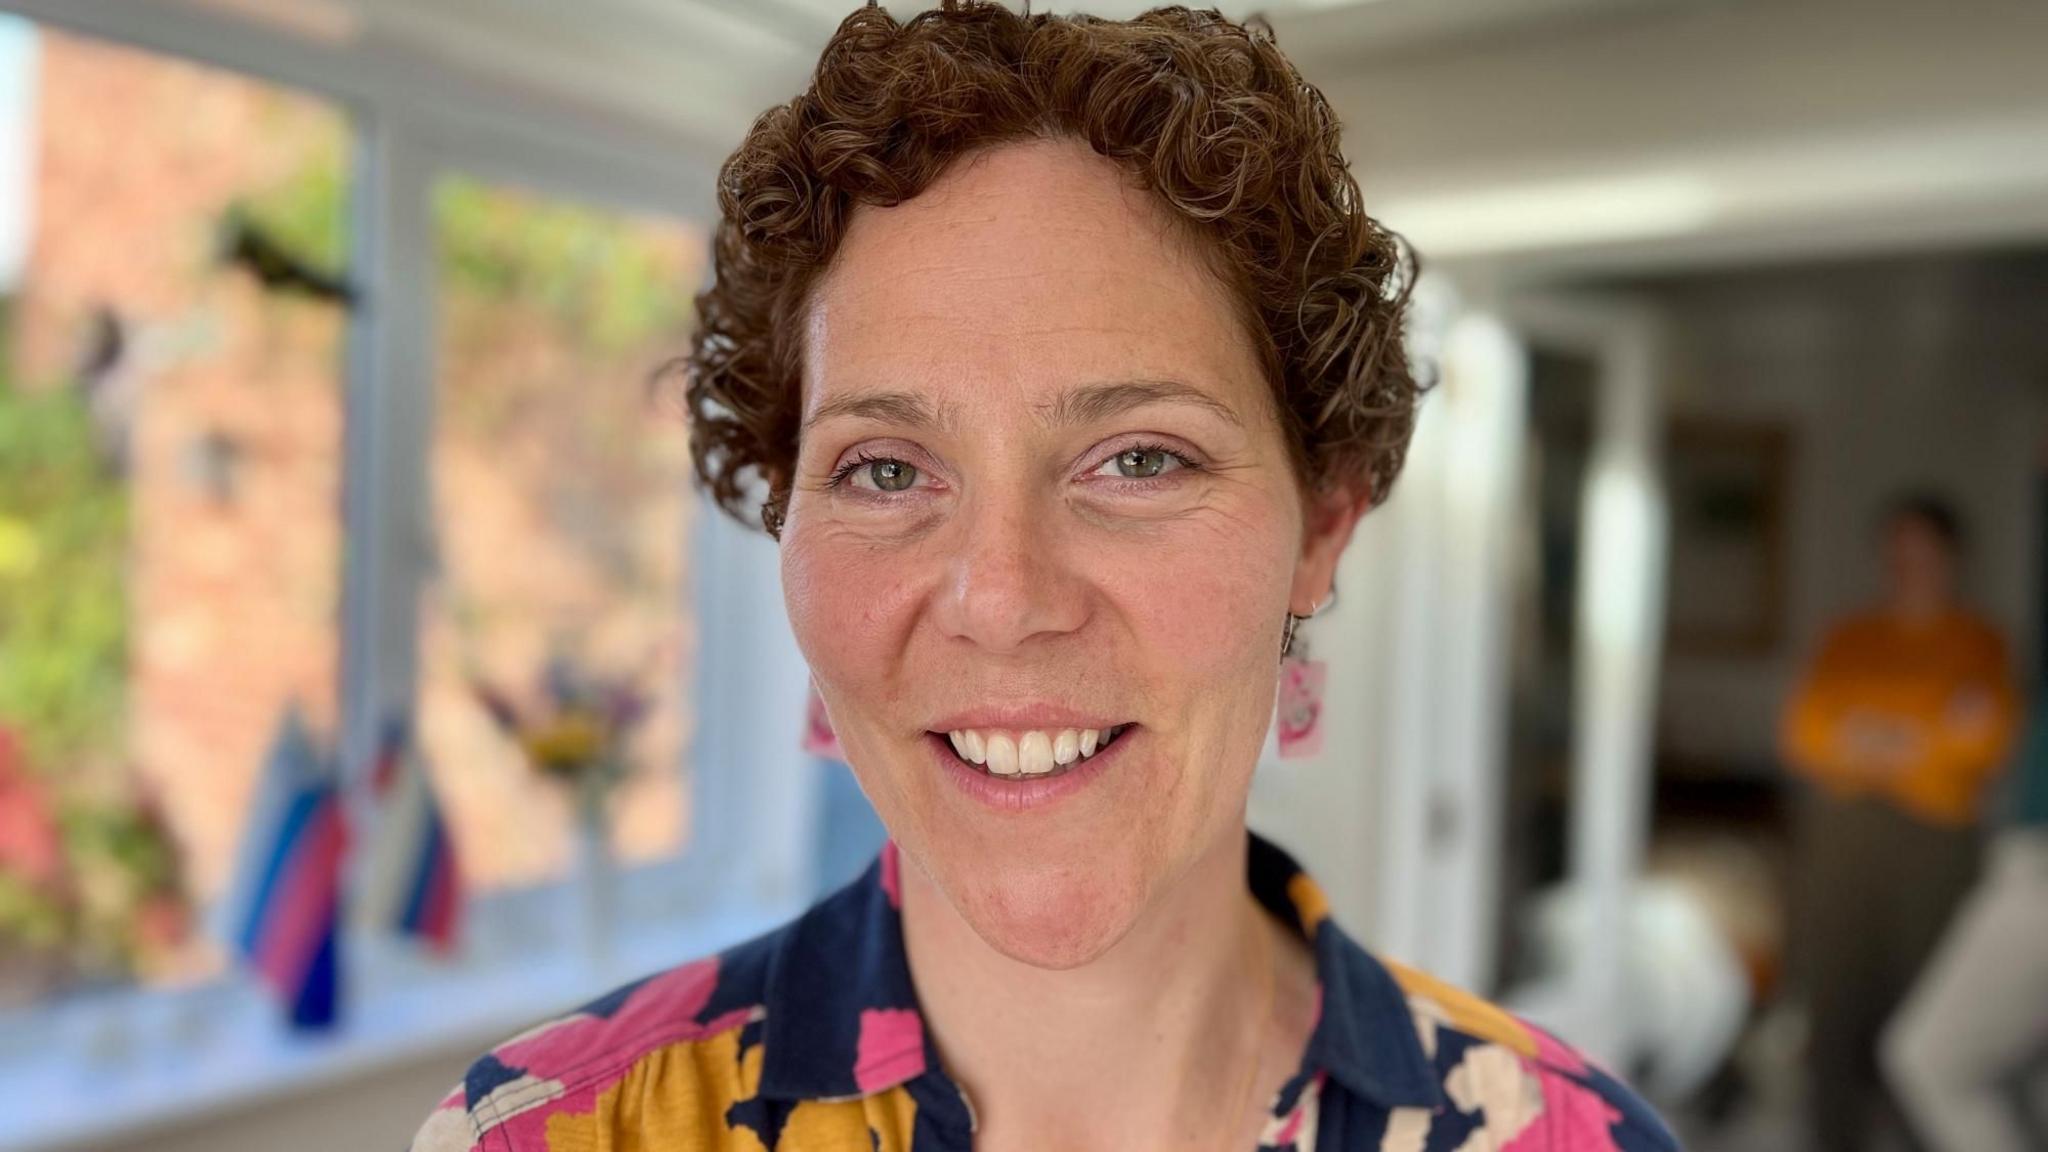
[0,11,794,1146]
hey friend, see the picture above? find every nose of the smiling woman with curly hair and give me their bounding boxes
[936,483,1087,652]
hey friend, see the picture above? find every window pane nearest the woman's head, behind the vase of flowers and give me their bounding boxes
[422,178,705,888]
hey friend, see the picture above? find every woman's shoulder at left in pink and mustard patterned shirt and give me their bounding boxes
[412,929,788,1152]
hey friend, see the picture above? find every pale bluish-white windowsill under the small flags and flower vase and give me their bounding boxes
[0,906,793,1152]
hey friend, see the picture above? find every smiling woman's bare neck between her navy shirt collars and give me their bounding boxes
[903,832,1278,1150]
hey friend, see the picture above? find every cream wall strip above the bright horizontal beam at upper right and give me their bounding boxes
[1318,0,2048,187]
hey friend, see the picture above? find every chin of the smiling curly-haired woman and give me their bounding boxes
[932,840,1145,970]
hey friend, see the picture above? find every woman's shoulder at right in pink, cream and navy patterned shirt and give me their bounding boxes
[1382,961,1679,1152]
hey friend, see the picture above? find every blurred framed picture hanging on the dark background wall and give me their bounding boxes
[1665,416,1792,656]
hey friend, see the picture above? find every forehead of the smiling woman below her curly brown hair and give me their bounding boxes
[803,139,1264,410]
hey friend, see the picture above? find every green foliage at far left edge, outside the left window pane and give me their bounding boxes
[0,326,184,988]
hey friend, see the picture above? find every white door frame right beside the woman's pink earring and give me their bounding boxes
[1331,279,1526,988]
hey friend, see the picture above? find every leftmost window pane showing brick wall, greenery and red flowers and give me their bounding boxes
[0,18,348,1000]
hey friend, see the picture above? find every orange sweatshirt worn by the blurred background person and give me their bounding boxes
[1782,611,2019,826]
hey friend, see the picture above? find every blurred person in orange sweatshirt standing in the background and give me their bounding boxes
[1782,494,2017,1152]
